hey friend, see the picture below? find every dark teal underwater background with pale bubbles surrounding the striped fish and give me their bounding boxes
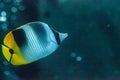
[0,0,120,80]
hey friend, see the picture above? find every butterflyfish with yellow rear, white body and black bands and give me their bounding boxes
[2,21,68,66]
